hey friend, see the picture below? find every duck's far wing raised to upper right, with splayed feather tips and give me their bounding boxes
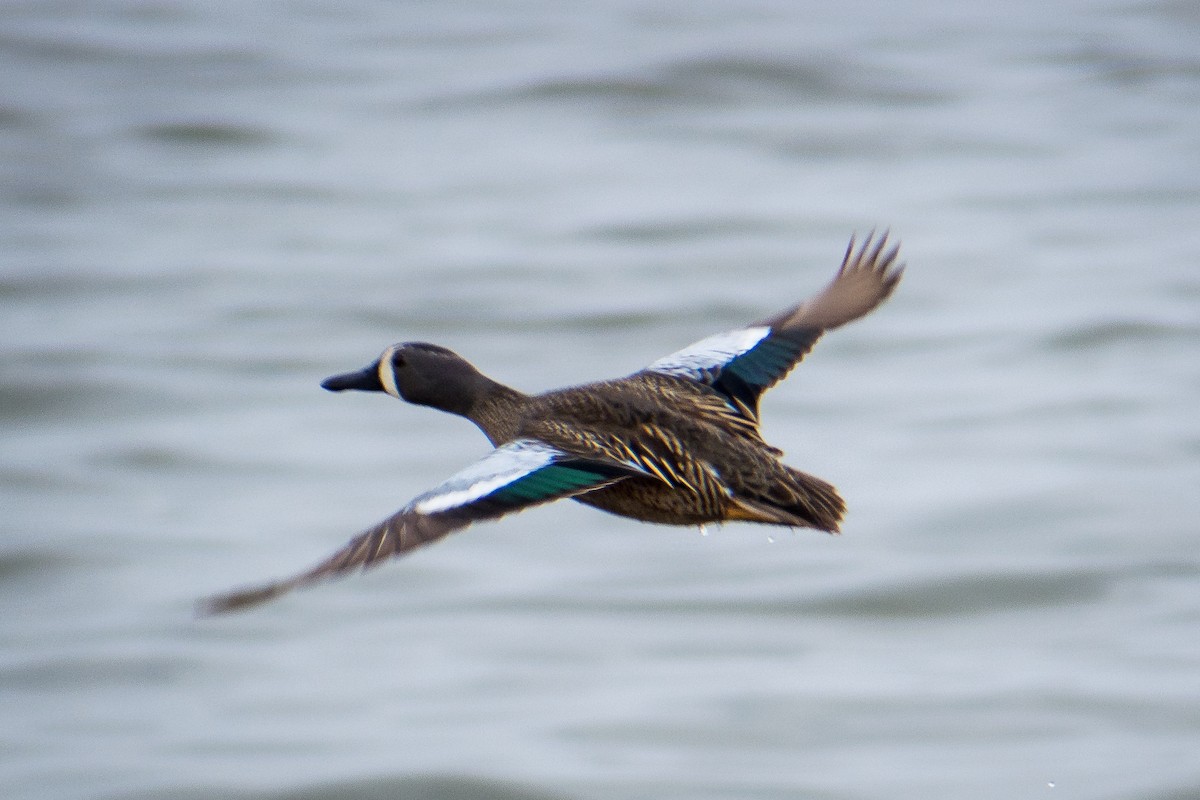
[646,233,904,422]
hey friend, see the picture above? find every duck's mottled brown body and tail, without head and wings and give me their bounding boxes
[521,372,842,530]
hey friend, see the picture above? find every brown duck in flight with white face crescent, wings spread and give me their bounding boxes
[199,234,904,614]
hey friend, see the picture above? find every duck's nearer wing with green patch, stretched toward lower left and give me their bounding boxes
[199,439,647,614]
